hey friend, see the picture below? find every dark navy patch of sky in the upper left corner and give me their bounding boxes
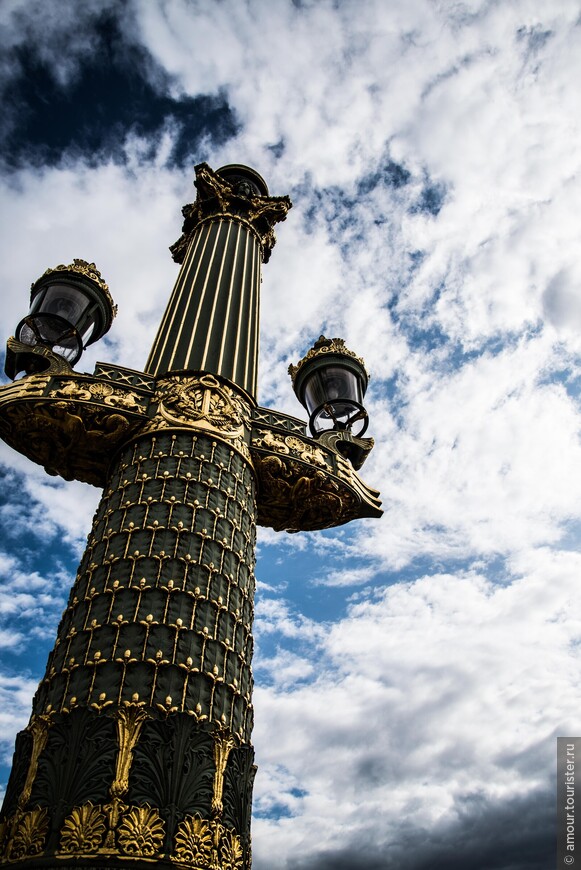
[0,9,238,168]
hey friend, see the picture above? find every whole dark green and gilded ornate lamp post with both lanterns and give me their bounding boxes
[0,164,381,870]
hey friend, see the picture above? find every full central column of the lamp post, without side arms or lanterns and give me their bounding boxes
[2,165,290,870]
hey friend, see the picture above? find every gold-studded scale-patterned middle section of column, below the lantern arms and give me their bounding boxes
[34,431,255,741]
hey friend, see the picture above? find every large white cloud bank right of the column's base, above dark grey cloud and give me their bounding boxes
[250,550,581,868]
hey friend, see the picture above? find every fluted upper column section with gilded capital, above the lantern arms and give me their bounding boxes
[146,164,290,396]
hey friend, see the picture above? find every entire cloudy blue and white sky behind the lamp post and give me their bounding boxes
[0,0,581,870]
